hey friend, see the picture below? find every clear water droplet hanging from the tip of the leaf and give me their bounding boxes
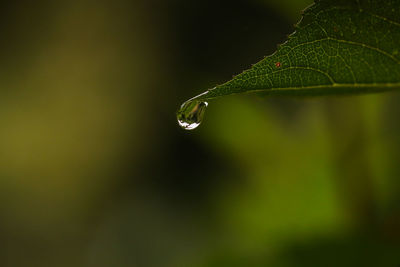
[177,100,208,130]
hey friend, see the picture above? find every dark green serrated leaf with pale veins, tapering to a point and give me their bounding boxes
[188,0,400,101]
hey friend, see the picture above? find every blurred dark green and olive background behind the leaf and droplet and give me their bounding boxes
[0,0,400,267]
